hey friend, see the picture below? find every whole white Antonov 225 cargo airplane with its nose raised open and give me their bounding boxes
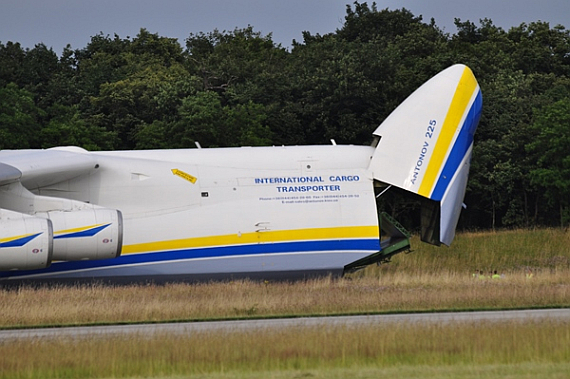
[0,64,482,284]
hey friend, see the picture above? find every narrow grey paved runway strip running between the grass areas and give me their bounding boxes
[0,309,570,342]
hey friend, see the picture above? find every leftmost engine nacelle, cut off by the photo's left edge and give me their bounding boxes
[0,209,53,271]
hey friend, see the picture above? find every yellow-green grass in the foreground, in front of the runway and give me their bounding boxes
[0,321,570,378]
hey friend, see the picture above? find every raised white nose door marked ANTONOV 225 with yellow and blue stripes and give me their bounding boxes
[370,64,483,245]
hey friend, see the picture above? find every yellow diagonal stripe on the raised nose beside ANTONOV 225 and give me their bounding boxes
[418,67,477,197]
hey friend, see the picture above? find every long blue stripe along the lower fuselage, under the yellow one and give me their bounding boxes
[0,239,380,278]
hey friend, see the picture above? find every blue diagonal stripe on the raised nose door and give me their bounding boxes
[430,90,483,201]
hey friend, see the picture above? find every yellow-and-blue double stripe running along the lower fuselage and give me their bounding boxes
[0,225,381,277]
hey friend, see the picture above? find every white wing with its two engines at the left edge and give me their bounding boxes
[0,148,122,271]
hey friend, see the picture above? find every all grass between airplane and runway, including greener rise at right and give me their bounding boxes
[0,229,570,327]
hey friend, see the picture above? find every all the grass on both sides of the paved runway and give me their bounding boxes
[0,229,570,378]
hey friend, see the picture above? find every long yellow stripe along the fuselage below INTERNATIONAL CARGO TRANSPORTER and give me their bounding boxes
[122,226,379,255]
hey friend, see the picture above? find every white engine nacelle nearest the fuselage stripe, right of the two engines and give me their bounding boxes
[36,207,123,261]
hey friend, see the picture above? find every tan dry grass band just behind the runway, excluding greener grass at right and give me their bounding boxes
[0,270,570,326]
